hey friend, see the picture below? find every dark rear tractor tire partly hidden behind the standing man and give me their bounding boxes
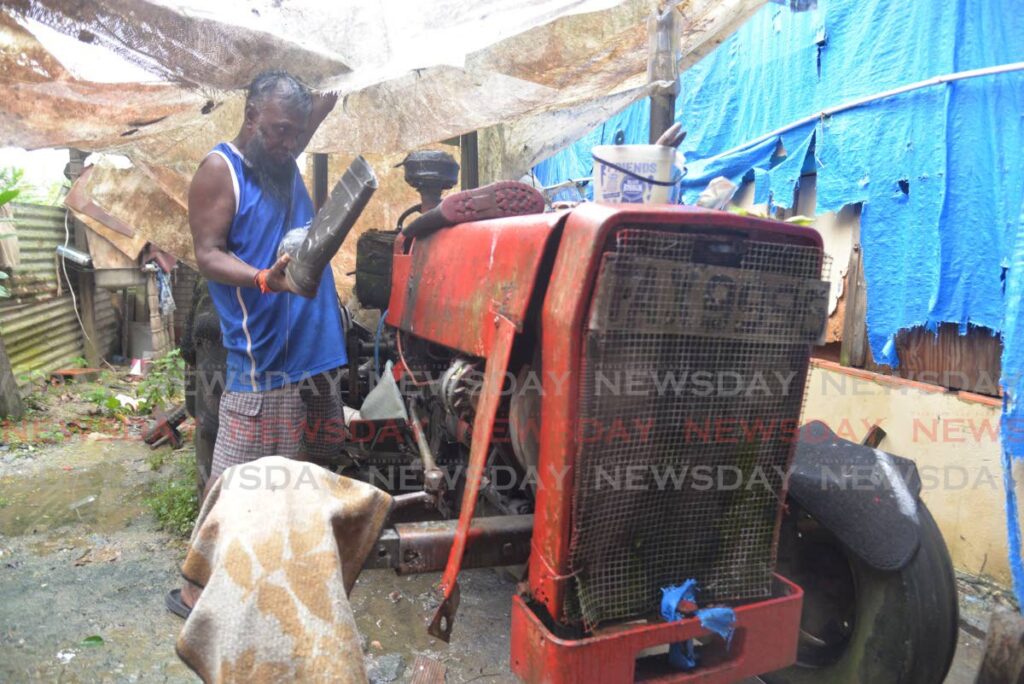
[182,277,227,496]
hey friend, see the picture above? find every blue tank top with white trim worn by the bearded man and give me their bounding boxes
[203,142,347,392]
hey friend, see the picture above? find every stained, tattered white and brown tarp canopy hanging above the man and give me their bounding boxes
[0,0,764,274]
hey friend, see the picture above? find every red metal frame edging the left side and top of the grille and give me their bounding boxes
[529,204,821,621]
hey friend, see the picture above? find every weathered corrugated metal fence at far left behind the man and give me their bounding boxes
[0,204,119,387]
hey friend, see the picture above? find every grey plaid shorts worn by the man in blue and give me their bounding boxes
[210,369,346,480]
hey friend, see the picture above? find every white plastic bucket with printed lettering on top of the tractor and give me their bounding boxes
[591,144,686,204]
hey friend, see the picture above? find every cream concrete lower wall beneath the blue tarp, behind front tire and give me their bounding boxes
[804,360,1024,587]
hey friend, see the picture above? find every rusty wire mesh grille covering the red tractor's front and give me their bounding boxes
[570,229,828,628]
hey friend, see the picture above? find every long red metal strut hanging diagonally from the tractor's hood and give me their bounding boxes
[427,315,516,642]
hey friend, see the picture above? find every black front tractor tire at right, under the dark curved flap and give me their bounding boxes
[761,500,958,684]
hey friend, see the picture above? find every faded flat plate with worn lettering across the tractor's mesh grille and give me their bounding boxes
[590,254,829,343]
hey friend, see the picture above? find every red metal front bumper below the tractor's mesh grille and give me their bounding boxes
[511,575,804,684]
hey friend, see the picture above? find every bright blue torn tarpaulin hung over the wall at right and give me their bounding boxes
[535,0,1024,610]
